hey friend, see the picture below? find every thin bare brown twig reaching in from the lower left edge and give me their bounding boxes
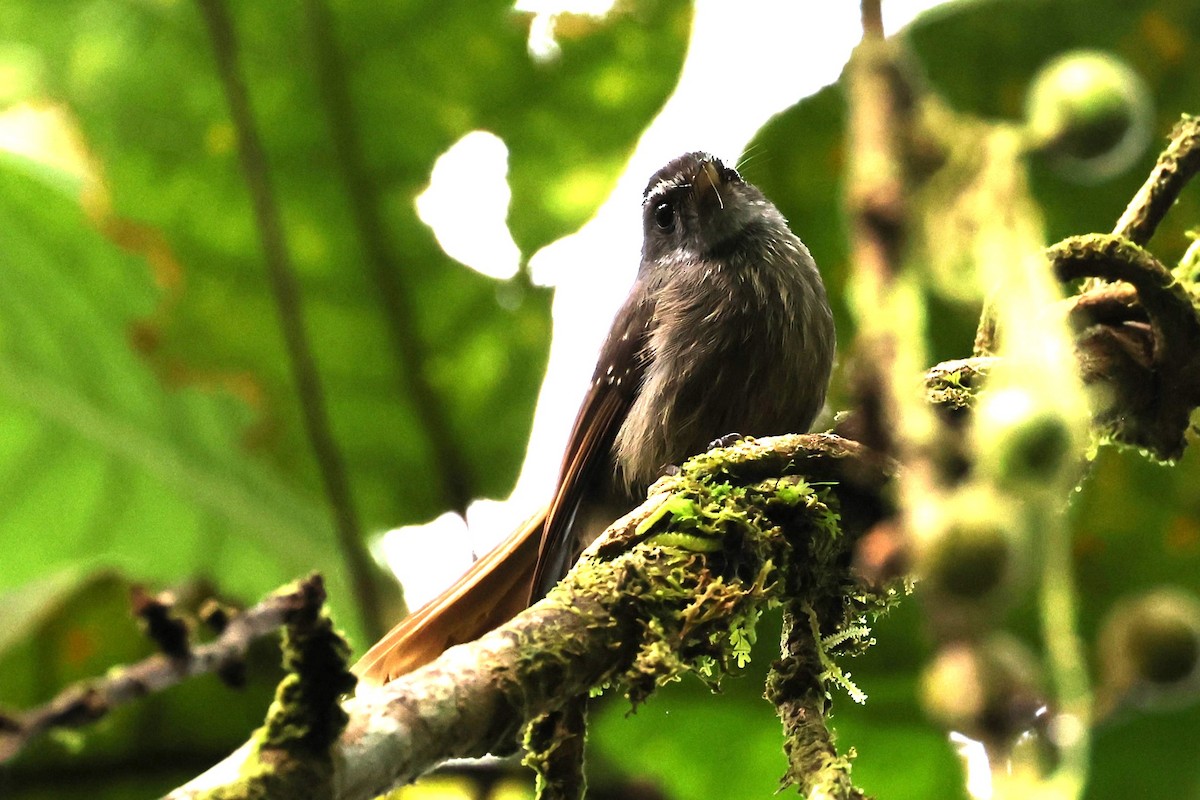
[0,576,325,763]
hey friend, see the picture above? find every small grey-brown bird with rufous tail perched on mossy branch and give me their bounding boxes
[353,151,836,685]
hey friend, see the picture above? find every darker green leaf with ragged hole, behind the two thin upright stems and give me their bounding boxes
[5,0,686,529]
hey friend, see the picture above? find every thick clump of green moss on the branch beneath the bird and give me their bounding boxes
[577,440,895,704]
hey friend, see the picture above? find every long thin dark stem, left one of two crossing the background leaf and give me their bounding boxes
[197,0,385,637]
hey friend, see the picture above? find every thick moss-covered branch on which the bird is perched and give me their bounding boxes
[168,434,887,800]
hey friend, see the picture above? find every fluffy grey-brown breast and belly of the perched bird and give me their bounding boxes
[614,247,832,492]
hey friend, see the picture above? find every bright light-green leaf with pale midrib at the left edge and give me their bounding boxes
[0,158,344,614]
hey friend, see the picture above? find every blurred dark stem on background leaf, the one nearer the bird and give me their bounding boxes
[305,0,472,512]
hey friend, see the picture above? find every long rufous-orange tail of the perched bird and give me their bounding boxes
[352,510,546,685]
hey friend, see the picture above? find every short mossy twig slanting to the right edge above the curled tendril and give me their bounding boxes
[1112,114,1200,245]
